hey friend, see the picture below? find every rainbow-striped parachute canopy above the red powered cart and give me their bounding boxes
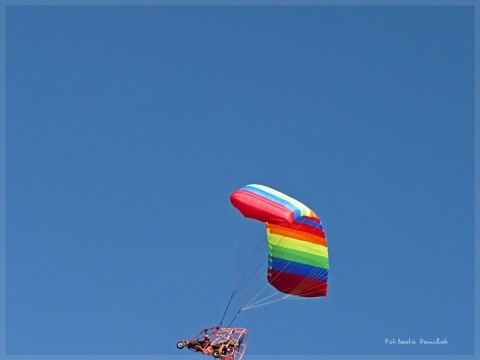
[230,184,329,297]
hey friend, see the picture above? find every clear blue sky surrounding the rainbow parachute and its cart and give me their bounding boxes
[6,7,475,359]
